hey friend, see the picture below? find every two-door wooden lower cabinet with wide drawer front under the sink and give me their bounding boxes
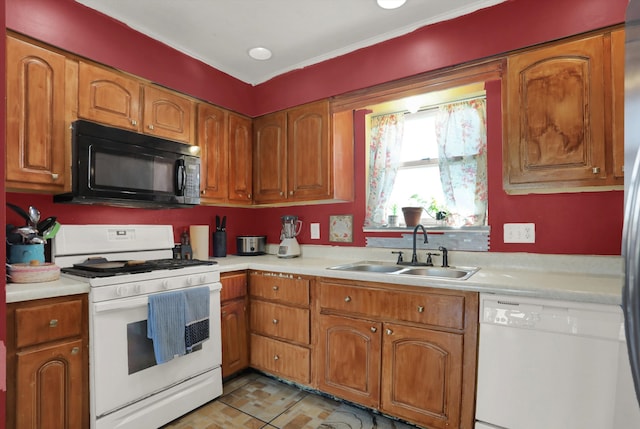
[315,279,478,429]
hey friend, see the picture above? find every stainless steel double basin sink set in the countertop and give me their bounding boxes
[328,261,480,280]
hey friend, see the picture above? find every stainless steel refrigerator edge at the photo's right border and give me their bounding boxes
[622,0,640,403]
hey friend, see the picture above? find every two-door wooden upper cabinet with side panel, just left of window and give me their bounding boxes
[253,100,354,204]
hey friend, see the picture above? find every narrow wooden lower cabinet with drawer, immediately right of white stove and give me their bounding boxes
[220,271,249,378]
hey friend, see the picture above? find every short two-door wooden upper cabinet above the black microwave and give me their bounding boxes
[78,62,195,143]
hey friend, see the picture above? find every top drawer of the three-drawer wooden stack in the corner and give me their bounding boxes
[249,273,309,307]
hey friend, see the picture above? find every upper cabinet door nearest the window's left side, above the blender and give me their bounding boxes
[287,100,331,201]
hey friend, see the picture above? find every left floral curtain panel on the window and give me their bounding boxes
[365,113,404,226]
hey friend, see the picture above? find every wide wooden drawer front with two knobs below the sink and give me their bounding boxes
[320,283,464,329]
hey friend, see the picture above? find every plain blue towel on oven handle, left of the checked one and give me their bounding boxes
[147,291,186,364]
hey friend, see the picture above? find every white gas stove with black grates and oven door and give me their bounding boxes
[52,225,222,429]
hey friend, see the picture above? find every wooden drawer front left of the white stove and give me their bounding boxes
[15,300,82,348]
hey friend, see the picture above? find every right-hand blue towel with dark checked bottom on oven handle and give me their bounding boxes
[184,286,210,352]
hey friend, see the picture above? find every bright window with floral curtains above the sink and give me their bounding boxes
[365,95,487,227]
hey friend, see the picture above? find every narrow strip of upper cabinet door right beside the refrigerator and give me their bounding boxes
[610,30,625,178]
